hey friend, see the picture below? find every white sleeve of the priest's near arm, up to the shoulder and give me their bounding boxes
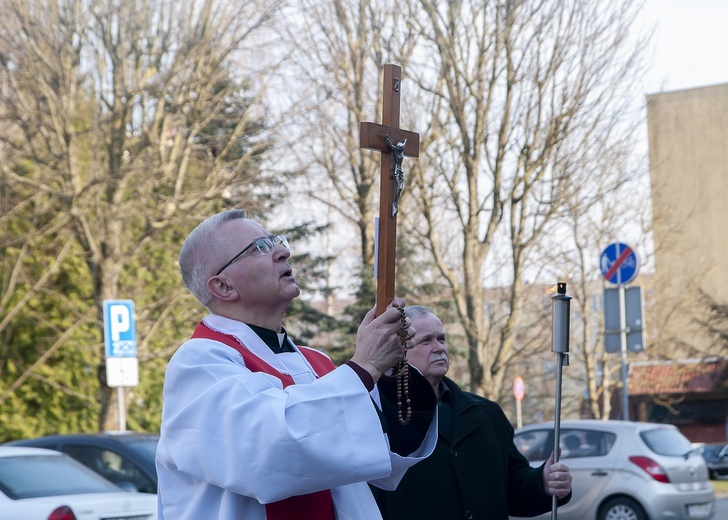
[158,339,392,503]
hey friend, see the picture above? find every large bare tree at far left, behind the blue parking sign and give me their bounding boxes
[0,0,276,429]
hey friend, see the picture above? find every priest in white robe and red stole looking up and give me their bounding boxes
[156,210,437,520]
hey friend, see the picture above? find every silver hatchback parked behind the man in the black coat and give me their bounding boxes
[514,420,715,520]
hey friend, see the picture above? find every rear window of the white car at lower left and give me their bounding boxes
[0,455,119,499]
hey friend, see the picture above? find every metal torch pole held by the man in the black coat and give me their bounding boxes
[551,282,571,520]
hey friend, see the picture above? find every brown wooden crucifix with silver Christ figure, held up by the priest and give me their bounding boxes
[359,64,420,316]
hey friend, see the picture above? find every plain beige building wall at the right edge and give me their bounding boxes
[646,84,728,357]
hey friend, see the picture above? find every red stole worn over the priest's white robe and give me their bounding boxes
[192,321,336,520]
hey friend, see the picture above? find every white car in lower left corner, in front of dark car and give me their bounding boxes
[0,446,157,520]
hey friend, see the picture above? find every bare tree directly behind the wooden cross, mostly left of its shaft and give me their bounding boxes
[282,0,415,306]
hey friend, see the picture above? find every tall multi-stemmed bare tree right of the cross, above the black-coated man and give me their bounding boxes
[410,0,643,395]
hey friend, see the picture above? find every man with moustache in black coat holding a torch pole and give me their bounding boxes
[373,306,571,520]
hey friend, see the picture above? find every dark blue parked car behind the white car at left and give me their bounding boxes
[5,432,159,493]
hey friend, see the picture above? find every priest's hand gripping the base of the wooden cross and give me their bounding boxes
[351,298,415,383]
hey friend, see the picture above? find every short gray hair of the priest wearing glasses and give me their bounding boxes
[179,209,248,308]
